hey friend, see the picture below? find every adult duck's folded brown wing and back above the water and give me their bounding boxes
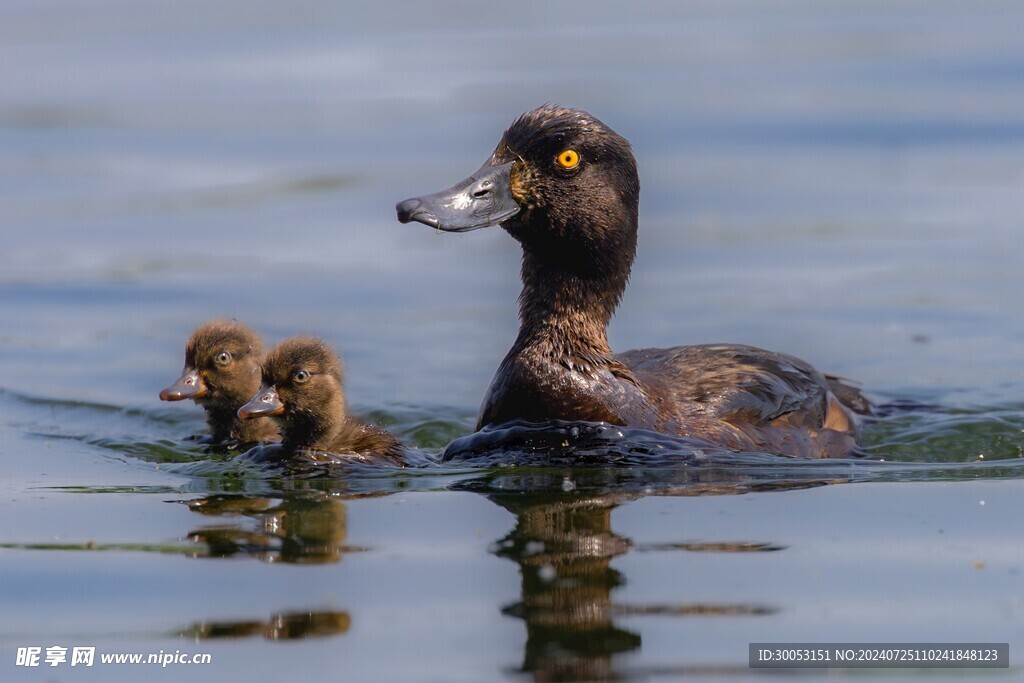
[616,344,869,456]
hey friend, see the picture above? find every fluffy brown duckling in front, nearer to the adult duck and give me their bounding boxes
[239,337,404,466]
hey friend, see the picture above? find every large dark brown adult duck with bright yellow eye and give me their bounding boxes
[396,104,869,458]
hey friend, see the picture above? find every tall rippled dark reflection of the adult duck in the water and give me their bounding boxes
[488,493,781,681]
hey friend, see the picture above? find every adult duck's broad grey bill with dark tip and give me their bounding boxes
[395,162,519,232]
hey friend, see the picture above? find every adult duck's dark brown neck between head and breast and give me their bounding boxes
[513,236,633,372]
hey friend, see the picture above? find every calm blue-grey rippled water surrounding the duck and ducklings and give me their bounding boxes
[0,0,1024,681]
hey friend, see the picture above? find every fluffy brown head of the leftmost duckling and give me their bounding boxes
[160,321,263,411]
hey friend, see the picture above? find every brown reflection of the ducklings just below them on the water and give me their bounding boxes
[182,495,366,564]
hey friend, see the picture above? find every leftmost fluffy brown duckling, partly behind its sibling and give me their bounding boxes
[160,319,279,449]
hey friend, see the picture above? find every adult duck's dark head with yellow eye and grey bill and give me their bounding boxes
[396,104,640,259]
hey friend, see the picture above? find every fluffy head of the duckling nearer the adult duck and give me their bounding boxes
[239,337,344,423]
